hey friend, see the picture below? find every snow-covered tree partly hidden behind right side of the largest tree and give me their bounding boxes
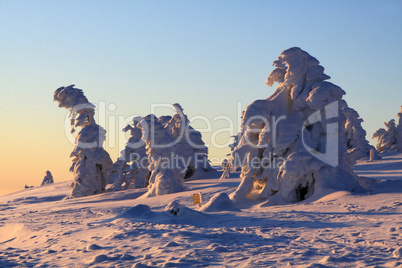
[342,106,381,164]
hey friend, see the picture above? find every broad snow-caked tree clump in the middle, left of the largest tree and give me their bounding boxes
[138,103,212,196]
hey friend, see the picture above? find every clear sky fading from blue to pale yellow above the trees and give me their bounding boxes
[0,0,402,193]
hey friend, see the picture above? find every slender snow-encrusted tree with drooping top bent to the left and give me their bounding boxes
[53,85,112,198]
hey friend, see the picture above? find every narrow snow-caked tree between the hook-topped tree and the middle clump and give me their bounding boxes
[109,117,149,191]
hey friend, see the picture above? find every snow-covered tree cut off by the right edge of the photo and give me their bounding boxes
[373,106,402,153]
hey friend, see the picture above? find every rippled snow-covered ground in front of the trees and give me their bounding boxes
[0,154,402,267]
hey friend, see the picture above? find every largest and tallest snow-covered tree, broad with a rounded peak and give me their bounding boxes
[226,47,363,202]
